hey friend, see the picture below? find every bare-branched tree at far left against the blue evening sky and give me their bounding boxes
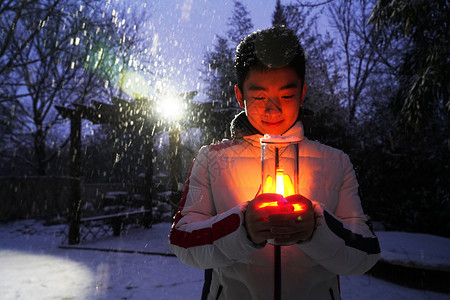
[0,0,153,175]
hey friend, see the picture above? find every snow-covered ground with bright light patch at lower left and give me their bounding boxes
[0,220,450,300]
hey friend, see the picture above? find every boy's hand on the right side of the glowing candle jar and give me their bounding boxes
[267,194,315,245]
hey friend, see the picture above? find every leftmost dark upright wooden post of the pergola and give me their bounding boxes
[69,113,81,245]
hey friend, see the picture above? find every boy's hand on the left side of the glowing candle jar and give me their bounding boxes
[245,194,292,245]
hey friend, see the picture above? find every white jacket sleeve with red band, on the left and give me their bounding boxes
[170,147,259,269]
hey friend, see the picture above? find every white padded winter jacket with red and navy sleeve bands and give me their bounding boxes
[170,122,380,300]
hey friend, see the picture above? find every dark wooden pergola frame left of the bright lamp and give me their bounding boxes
[55,98,157,244]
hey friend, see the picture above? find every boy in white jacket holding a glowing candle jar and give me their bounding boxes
[170,27,380,299]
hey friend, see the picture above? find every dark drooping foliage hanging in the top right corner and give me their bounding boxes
[370,0,450,129]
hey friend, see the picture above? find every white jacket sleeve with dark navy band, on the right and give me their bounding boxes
[298,154,380,275]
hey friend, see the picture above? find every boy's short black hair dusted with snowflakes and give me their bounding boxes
[234,26,305,91]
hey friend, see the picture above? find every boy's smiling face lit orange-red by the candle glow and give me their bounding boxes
[235,67,306,135]
